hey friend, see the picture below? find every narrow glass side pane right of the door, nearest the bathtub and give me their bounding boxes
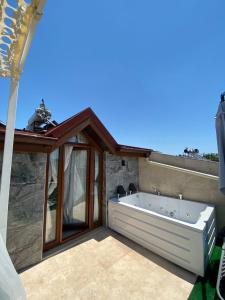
[94,151,100,222]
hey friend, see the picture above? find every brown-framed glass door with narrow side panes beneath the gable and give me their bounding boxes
[44,142,103,250]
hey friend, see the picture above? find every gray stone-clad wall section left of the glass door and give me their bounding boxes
[0,152,47,270]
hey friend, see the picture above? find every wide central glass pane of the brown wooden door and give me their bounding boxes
[62,145,89,240]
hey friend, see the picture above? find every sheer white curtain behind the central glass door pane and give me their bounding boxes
[63,146,87,224]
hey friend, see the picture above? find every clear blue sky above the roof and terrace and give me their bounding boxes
[0,0,225,154]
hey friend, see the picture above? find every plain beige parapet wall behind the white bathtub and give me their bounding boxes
[139,153,225,229]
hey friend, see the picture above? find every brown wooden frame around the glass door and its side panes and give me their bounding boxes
[43,141,104,251]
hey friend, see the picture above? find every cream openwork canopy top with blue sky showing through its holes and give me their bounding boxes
[0,0,42,78]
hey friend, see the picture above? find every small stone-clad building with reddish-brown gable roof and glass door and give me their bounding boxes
[0,108,151,270]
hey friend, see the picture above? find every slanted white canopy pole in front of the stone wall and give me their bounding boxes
[0,77,19,243]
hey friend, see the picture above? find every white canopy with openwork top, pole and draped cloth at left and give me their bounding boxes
[0,0,45,300]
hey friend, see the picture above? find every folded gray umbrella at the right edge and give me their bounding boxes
[216,93,225,194]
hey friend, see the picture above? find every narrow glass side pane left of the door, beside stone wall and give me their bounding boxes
[45,149,59,243]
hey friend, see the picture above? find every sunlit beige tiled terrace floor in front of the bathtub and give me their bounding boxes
[20,228,195,300]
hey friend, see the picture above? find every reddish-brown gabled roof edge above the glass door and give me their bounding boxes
[0,107,152,157]
